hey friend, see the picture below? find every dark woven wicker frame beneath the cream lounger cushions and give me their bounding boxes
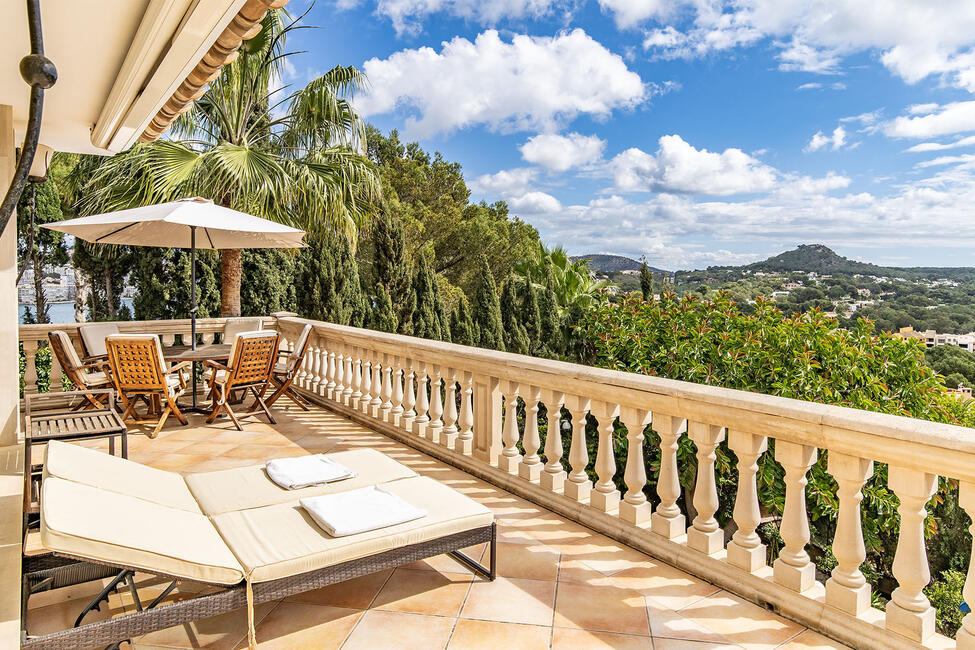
[21,524,497,650]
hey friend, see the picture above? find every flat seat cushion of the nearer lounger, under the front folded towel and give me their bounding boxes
[212,476,494,582]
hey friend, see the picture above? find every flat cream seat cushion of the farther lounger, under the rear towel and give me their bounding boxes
[186,449,416,515]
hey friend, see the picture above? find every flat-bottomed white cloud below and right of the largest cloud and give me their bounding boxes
[609,135,776,196]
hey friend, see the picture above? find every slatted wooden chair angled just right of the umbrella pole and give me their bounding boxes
[203,331,278,431]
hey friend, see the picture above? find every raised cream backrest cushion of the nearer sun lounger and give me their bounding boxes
[41,476,244,585]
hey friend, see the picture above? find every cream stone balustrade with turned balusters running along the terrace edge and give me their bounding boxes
[21,314,975,649]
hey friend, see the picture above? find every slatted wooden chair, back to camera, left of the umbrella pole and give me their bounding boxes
[105,334,192,438]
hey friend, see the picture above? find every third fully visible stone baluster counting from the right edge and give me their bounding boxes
[772,440,817,593]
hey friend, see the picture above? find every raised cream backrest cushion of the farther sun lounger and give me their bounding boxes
[44,440,200,514]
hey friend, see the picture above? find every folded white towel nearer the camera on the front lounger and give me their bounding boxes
[300,485,427,537]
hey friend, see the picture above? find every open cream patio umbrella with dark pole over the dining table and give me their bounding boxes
[41,197,305,403]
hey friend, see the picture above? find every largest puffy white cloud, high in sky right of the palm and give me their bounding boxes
[356,29,649,137]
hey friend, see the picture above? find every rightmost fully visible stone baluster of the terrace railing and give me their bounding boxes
[887,465,938,643]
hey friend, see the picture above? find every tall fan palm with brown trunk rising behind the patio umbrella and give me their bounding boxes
[75,10,380,316]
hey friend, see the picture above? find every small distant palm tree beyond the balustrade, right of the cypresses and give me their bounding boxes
[515,242,611,313]
